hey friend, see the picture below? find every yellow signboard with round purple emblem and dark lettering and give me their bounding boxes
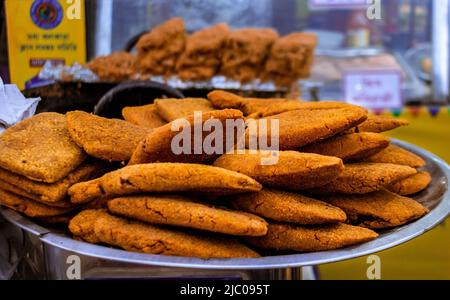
[5,0,86,89]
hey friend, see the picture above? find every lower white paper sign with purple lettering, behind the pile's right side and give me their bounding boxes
[343,70,403,109]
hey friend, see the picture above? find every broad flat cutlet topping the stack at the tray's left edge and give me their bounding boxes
[0,113,86,183]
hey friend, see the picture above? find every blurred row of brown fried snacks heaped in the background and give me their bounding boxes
[87,18,317,86]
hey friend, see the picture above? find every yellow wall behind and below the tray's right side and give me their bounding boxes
[320,108,450,280]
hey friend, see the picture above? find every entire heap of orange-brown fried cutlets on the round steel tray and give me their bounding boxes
[0,91,431,258]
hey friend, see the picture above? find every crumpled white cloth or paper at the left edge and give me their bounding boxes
[0,78,41,129]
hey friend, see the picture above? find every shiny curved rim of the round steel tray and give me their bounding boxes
[0,139,450,270]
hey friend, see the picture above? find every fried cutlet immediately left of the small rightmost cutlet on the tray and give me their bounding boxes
[309,163,417,195]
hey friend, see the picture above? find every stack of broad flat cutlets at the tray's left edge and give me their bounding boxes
[0,113,105,222]
